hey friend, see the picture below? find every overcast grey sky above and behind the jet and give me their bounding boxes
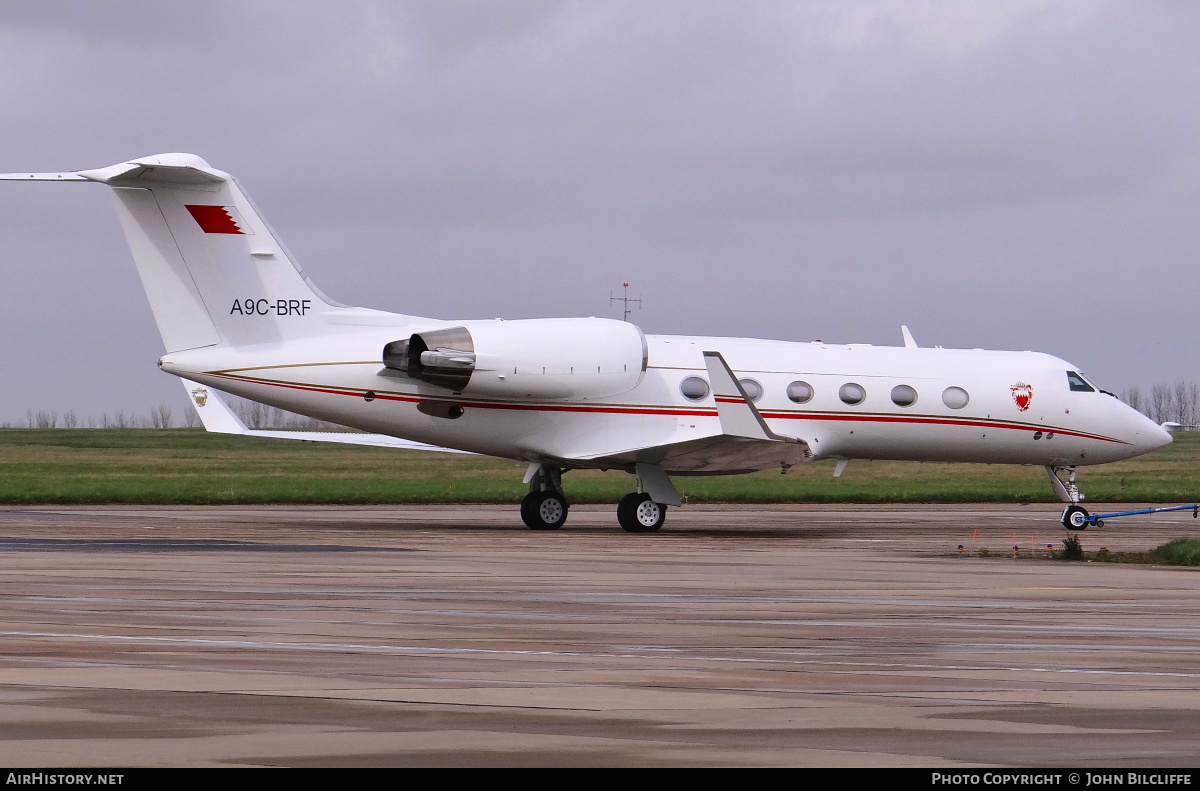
[0,0,1200,420]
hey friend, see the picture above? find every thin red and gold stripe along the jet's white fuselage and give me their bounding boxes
[208,373,1129,445]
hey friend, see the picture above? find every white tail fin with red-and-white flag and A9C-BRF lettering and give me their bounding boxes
[0,154,341,352]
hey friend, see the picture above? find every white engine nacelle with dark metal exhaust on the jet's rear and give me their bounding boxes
[383,318,647,399]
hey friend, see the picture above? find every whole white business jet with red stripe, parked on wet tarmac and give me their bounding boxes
[0,154,1171,533]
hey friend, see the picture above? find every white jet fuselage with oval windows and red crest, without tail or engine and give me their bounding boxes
[161,316,1170,474]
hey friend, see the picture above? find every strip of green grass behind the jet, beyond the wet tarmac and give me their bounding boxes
[0,429,1200,504]
